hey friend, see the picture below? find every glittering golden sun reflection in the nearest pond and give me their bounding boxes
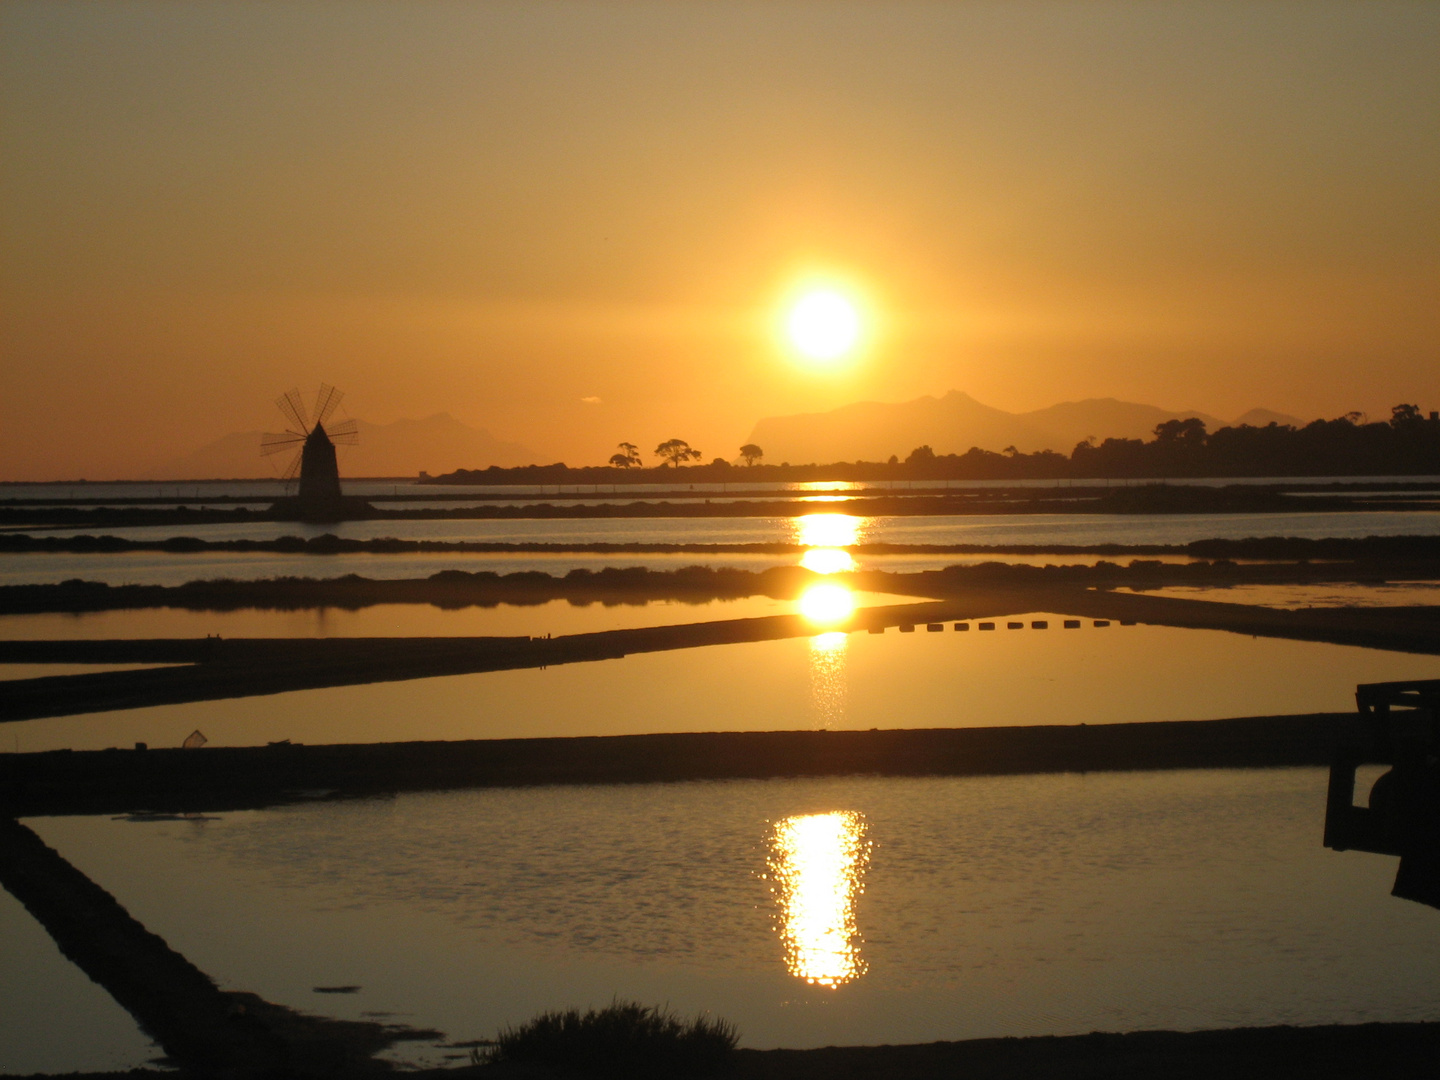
[769,811,870,986]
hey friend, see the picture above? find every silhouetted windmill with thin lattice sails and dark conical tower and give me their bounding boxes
[261,383,370,521]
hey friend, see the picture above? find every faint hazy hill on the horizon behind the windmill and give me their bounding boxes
[141,412,537,480]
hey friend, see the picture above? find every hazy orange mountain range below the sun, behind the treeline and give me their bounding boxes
[749,390,1303,465]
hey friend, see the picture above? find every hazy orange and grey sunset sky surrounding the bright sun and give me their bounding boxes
[0,0,1440,478]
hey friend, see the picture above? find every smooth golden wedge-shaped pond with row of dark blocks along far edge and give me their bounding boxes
[14,612,1440,750]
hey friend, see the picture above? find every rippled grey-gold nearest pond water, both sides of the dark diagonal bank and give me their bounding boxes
[8,769,1440,1071]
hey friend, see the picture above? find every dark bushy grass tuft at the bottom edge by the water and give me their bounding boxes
[490,1001,739,1079]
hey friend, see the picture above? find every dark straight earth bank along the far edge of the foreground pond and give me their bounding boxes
[0,713,1359,818]
